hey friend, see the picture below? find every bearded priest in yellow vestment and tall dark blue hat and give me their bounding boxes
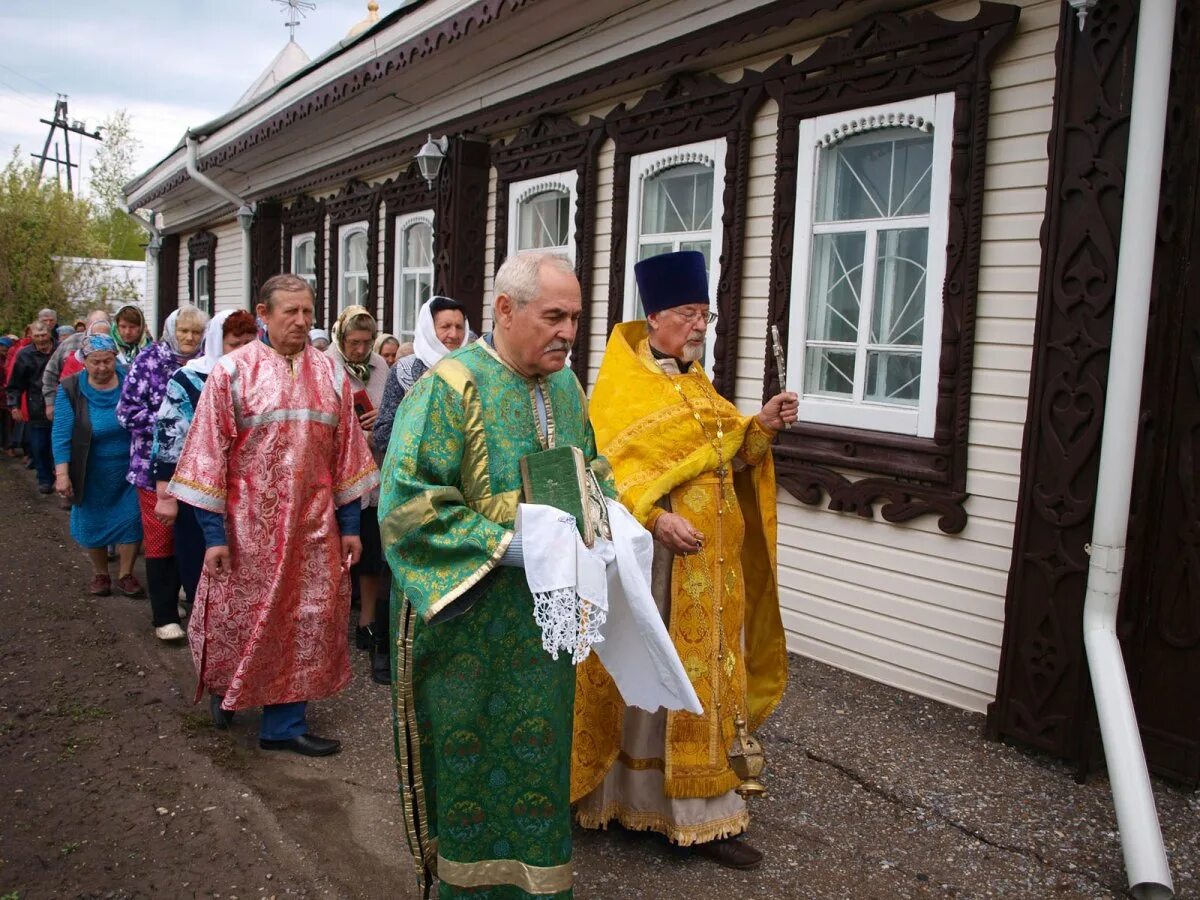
[571,251,798,869]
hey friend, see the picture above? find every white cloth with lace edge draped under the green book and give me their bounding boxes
[517,499,703,714]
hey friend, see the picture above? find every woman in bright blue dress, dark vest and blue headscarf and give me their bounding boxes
[52,335,142,596]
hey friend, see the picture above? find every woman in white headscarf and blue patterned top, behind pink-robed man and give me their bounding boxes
[150,310,258,624]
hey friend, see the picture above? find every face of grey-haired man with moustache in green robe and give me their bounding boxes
[496,266,583,377]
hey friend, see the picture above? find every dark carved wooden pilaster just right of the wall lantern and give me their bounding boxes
[433,137,490,336]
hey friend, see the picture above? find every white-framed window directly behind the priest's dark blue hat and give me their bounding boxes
[625,139,726,370]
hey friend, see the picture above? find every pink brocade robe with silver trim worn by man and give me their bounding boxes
[168,341,379,709]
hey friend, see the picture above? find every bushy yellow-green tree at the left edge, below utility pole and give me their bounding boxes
[0,148,106,334]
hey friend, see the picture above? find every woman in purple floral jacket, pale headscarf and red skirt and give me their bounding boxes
[116,304,209,643]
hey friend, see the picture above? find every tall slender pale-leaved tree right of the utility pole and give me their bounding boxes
[89,109,146,259]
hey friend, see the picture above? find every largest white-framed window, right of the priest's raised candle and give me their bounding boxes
[787,94,954,437]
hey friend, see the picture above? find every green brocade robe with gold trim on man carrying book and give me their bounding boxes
[379,341,614,900]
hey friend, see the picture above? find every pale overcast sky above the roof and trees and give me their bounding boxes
[0,0,379,194]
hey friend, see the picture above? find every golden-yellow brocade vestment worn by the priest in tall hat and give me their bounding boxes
[571,322,787,802]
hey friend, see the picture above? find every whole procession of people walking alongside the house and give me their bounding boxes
[0,252,798,898]
